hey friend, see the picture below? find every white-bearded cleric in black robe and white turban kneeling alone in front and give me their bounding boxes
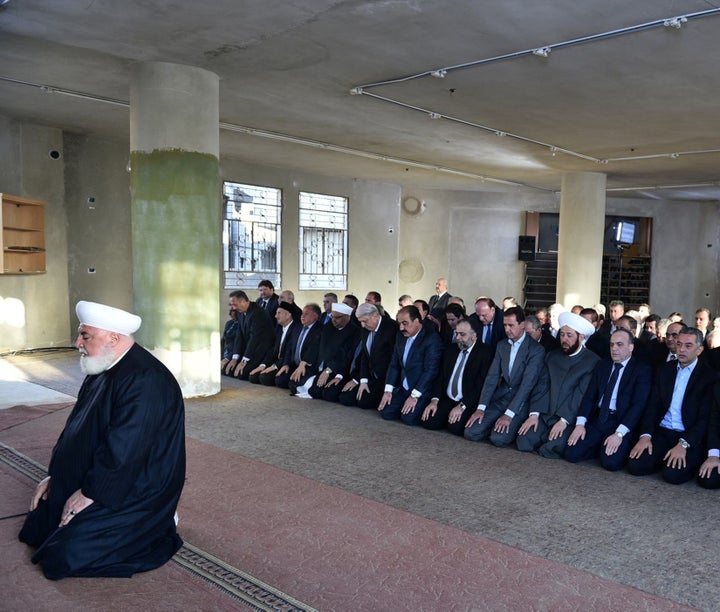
[20,302,185,580]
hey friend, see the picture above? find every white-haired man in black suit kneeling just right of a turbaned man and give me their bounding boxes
[338,302,398,409]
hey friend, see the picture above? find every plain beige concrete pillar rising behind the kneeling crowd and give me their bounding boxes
[556,172,607,308]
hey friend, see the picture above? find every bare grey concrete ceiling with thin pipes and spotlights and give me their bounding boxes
[0,0,720,200]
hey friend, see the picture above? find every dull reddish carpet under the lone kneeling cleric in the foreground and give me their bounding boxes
[0,400,685,611]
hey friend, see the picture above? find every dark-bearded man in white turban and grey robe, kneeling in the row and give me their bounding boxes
[516,312,600,458]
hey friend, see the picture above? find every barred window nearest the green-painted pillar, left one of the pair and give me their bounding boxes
[223,181,282,289]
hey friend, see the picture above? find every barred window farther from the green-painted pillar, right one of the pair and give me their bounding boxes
[298,191,348,290]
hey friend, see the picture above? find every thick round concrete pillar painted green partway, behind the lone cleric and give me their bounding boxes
[130,62,221,397]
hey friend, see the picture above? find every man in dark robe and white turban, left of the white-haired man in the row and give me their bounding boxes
[304,303,360,402]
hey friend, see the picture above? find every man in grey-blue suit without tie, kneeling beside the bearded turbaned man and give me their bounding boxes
[465,306,545,446]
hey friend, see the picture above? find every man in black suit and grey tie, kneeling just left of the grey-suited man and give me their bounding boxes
[420,320,492,436]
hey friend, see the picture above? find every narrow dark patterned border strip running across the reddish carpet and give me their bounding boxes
[0,442,317,612]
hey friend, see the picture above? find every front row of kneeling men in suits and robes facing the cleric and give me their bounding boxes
[223,290,720,488]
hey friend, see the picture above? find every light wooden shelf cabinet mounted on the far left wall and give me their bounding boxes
[0,193,45,274]
